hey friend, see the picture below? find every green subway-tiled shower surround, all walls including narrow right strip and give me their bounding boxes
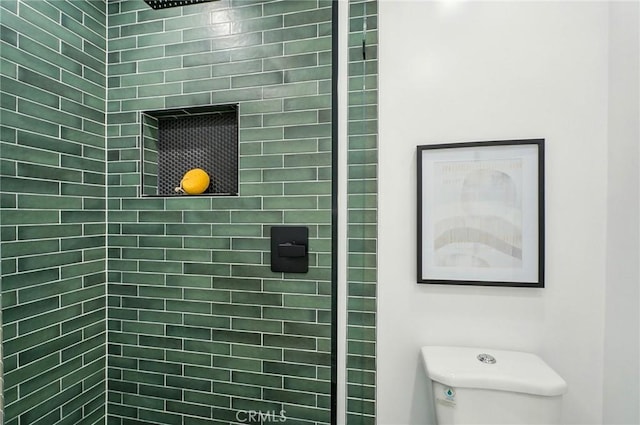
[0,0,377,425]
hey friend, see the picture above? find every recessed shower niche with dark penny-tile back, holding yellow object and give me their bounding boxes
[140,104,238,196]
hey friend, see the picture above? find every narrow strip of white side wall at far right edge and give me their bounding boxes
[603,2,640,424]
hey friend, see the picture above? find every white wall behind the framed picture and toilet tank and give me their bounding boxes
[378,0,609,425]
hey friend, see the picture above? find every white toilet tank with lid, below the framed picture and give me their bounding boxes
[422,346,567,425]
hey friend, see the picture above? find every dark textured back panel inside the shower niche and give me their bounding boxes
[157,111,238,195]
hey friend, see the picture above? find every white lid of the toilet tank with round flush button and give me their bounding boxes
[422,346,567,396]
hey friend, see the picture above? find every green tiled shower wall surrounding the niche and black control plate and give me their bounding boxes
[107,0,332,424]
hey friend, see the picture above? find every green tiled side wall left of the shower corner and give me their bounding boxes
[0,0,106,425]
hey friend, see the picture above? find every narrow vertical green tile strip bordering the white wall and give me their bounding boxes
[346,0,378,425]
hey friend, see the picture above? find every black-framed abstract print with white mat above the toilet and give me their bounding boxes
[417,139,544,288]
